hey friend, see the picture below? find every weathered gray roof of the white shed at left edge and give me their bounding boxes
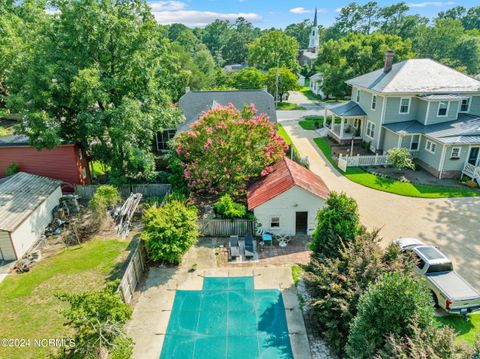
[0,172,61,232]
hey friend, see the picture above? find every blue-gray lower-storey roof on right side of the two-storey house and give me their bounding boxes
[383,114,480,145]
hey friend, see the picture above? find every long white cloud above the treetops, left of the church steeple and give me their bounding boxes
[152,10,262,26]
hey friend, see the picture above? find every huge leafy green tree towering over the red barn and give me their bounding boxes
[8,0,184,179]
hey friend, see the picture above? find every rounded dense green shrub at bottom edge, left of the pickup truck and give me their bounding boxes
[347,273,433,359]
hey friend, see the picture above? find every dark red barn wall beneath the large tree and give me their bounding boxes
[0,145,90,184]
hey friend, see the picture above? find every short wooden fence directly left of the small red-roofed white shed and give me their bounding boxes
[198,219,255,237]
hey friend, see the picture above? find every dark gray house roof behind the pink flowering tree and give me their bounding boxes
[177,90,277,131]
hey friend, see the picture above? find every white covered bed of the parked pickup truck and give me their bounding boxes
[426,271,480,301]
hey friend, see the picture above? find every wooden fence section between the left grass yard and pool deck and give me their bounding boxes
[118,241,147,304]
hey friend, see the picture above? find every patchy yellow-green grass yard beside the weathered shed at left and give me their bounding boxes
[0,239,128,359]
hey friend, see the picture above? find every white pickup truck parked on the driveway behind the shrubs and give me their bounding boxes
[394,238,480,315]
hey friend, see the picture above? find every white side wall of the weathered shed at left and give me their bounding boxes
[11,186,62,258]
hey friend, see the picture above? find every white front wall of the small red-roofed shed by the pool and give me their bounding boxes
[253,186,325,239]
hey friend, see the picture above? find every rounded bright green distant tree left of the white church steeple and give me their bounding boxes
[248,30,299,70]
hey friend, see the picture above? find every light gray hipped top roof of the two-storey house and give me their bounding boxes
[347,59,480,94]
